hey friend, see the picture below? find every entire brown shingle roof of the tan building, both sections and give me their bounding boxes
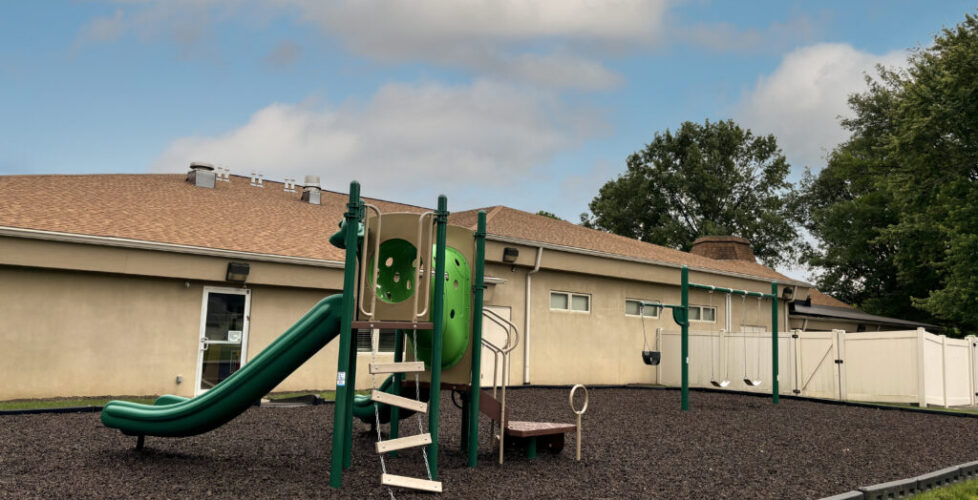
[0,174,793,281]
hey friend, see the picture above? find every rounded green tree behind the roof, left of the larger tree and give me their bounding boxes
[581,120,801,265]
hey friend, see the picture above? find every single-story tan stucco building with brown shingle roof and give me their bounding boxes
[0,168,932,400]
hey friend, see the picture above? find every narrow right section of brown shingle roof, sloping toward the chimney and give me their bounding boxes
[450,206,796,283]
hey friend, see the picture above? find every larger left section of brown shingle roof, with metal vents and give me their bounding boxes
[0,174,422,261]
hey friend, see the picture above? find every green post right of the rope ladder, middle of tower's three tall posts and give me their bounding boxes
[428,195,448,480]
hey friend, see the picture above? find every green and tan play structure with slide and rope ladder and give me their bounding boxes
[102,182,587,492]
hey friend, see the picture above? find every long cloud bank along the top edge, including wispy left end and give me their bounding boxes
[76,0,671,90]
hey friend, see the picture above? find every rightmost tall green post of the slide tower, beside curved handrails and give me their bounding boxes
[467,210,486,467]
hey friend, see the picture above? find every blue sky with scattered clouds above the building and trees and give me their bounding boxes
[0,0,974,278]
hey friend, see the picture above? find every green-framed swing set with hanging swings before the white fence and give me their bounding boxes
[639,266,780,411]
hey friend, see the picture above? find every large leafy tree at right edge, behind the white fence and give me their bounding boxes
[803,15,978,332]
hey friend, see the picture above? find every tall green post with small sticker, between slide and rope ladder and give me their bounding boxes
[329,181,360,488]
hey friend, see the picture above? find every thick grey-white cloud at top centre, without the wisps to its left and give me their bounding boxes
[282,0,667,90]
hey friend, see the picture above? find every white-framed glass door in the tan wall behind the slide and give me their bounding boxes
[194,287,251,395]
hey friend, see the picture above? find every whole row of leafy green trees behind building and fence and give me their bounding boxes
[581,14,978,334]
